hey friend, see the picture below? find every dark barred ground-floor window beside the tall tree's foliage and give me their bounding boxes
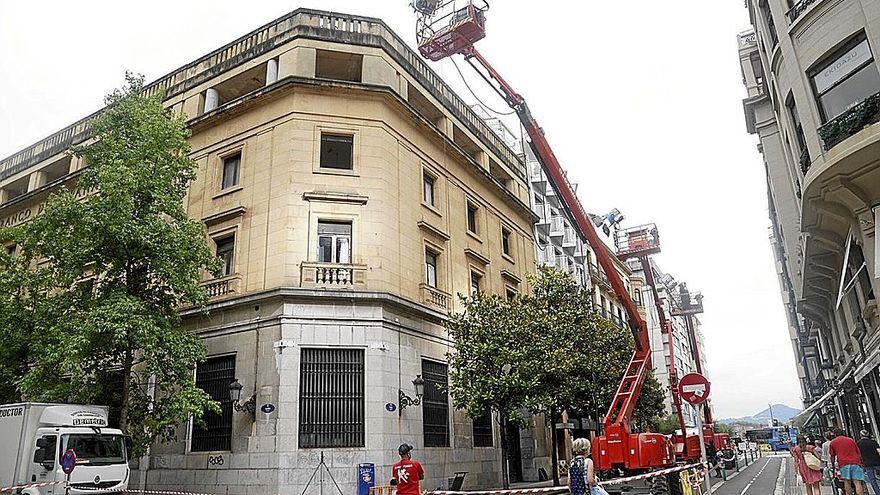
[191,355,235,452]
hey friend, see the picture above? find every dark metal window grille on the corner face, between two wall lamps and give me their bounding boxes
[299,348,364,448]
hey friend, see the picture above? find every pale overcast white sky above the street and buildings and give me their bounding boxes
[0,0,801,418]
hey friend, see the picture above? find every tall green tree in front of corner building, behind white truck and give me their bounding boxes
[9,74,219,453]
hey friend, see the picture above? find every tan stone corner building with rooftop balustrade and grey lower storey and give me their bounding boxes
[0,9,535,495]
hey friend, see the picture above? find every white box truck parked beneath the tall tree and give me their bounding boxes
[0,402,130,495]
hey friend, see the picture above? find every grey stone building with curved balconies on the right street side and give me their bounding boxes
[738,0,880,435]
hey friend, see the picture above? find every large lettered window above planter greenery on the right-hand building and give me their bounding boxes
[810,34,880,122]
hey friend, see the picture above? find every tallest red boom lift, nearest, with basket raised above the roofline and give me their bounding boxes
[412,0,675,471]
